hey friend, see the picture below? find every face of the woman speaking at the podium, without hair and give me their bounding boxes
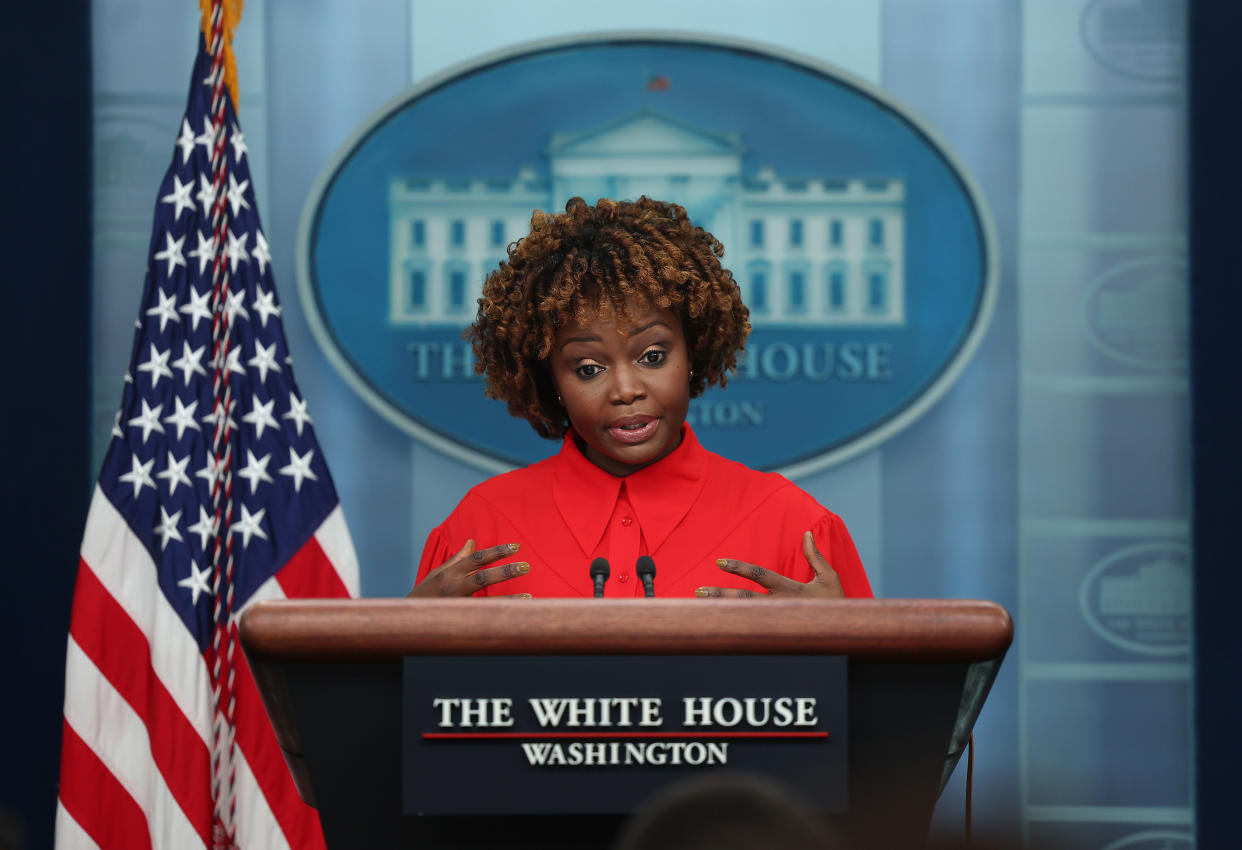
[549,307,691,476]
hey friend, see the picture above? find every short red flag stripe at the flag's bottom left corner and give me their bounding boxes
[60,722,152,850]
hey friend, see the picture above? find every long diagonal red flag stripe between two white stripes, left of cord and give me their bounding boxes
[70,560,211,844]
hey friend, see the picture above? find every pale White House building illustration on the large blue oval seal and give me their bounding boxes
[389,108,905,328]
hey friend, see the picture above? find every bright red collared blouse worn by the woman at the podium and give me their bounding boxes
[416,425,873,596]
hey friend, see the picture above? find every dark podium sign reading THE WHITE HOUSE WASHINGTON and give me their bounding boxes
[402,656,847,815]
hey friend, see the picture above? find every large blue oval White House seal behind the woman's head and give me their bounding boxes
[298,34,997,475]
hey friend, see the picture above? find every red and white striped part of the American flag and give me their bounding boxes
[56,490,358,850]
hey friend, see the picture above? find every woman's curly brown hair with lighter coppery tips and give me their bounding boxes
[466,198,750,439]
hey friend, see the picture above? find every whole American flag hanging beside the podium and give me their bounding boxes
[56,5,358,850]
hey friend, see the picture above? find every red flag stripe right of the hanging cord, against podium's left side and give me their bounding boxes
[226,631,330,850]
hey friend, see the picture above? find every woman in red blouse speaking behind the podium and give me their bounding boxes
[410,198,872,598]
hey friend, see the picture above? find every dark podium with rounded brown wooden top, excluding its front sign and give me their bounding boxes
[241,599,1013,849]
